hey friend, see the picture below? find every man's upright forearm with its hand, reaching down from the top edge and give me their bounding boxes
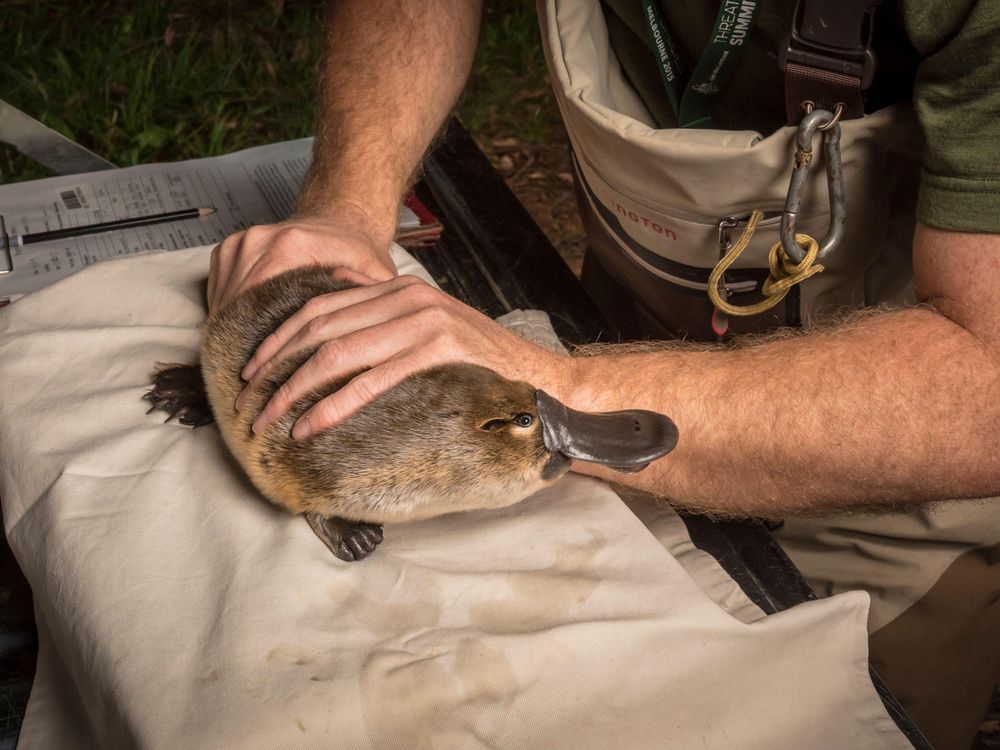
[209,0,480,309]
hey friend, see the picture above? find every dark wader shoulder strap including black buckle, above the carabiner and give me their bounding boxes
[779,0,881,125]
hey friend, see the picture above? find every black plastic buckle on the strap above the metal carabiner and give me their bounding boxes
[778,0,880,91]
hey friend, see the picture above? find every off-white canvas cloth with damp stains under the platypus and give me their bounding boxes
[0,248,909,750]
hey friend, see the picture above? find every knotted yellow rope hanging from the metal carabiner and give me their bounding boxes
[708,211,823,316]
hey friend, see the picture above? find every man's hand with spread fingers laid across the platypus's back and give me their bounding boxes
[237,269,574,439]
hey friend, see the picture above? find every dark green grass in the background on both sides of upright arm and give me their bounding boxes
[0,0,558,182]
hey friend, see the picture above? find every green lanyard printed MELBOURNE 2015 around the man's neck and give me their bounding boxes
[642,0,760,128]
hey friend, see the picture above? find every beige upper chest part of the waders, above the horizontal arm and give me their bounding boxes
[538,0,923,338]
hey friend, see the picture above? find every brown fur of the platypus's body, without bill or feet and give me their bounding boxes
[201,267,568,523]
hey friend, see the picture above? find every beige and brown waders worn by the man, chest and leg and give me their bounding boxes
[538,0,1000,750]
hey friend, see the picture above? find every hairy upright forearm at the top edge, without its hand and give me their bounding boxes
[298,0,479,250]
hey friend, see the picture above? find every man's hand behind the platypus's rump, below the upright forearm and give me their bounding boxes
[208,209,395,312]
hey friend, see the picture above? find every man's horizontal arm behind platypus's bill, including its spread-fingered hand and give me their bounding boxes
[244,226,1000,517]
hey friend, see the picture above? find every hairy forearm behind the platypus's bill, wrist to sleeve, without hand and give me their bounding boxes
[574,226,1000,516]
